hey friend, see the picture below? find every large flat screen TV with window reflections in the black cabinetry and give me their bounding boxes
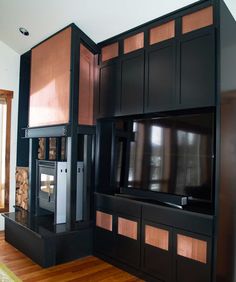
[117,112,214,206]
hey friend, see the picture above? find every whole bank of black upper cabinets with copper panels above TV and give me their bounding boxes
[99,5,216,117]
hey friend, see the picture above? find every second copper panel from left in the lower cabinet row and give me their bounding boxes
[118,217,138,240]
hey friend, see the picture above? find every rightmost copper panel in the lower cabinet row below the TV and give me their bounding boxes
[177,234,207,263]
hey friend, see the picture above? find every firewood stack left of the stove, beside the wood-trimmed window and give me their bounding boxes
[16,167,29,210]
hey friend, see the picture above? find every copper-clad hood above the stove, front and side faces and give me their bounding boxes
[29,25,97,127]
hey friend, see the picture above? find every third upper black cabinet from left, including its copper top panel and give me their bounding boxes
[145,20,176,112]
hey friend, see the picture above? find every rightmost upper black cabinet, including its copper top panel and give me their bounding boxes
[179,6,216,107]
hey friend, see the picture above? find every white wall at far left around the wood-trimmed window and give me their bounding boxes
[0,41,20,230]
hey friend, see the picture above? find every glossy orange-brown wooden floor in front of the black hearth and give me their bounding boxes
[0,232,142,282]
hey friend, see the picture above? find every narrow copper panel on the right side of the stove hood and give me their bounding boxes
[78,44,96,125]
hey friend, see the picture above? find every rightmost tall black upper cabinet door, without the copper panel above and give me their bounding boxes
[180,30,215,107]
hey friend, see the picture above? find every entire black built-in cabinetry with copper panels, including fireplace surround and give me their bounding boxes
[10,0,236,282]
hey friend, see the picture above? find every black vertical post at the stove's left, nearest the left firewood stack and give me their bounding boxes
[29,138,38,214]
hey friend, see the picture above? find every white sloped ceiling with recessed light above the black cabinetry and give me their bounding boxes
[0,0,236,54]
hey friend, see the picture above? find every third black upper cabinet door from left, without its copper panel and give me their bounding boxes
[145,41,176,112]
